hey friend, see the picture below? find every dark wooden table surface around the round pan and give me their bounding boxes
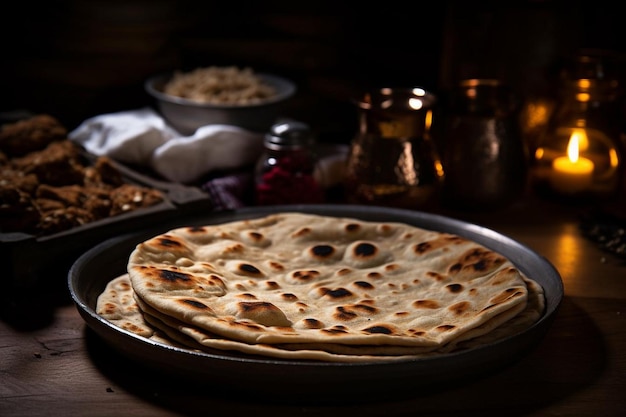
[0,199,626,417]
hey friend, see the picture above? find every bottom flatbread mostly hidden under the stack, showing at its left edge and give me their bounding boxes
[97,274,544,362]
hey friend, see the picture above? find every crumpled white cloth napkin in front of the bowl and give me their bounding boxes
[68,108,263,183]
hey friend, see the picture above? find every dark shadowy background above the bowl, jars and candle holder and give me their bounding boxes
[0,0,626,142]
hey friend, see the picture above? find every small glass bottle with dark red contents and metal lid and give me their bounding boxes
[255,121,324,205]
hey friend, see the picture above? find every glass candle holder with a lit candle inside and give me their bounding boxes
[532,51,623,201]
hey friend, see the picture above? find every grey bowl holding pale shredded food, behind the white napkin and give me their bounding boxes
[144,73,296,135]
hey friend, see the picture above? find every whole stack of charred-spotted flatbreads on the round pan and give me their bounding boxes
[97,212,545,362]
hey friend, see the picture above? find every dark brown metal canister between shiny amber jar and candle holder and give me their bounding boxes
[441,79,529,210]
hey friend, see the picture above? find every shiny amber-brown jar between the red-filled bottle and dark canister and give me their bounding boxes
[344,88,443,209]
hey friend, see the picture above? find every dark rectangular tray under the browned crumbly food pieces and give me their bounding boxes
[0,153,211,294]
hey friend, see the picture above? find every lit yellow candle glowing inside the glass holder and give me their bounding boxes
[551,132,594,194]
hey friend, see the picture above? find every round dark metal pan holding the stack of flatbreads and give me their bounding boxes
[68,205,563,401]
